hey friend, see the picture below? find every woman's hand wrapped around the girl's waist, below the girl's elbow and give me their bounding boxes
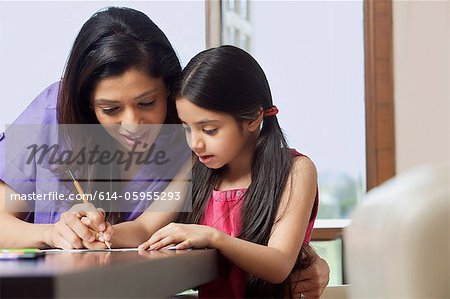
[289,246,330,299]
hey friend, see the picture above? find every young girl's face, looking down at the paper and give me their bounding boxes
[176,98,259,169]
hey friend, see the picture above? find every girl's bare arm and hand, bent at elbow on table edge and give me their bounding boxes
[140,157,317,283]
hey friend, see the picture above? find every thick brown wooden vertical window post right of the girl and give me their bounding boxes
[364,0,396,191]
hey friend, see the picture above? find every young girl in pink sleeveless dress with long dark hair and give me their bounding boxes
[139,46,318,298]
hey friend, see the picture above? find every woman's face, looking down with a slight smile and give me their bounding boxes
[91,69,169,151]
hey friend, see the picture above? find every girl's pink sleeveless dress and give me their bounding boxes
[199,150,319,298]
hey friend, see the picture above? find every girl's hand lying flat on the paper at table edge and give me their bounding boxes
[138,223,220,250]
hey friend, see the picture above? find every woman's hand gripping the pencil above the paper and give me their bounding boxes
[46,203,113,249]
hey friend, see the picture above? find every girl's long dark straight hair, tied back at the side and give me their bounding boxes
[177,46,310,298]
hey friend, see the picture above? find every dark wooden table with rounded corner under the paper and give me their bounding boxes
[0,249,218,298]
